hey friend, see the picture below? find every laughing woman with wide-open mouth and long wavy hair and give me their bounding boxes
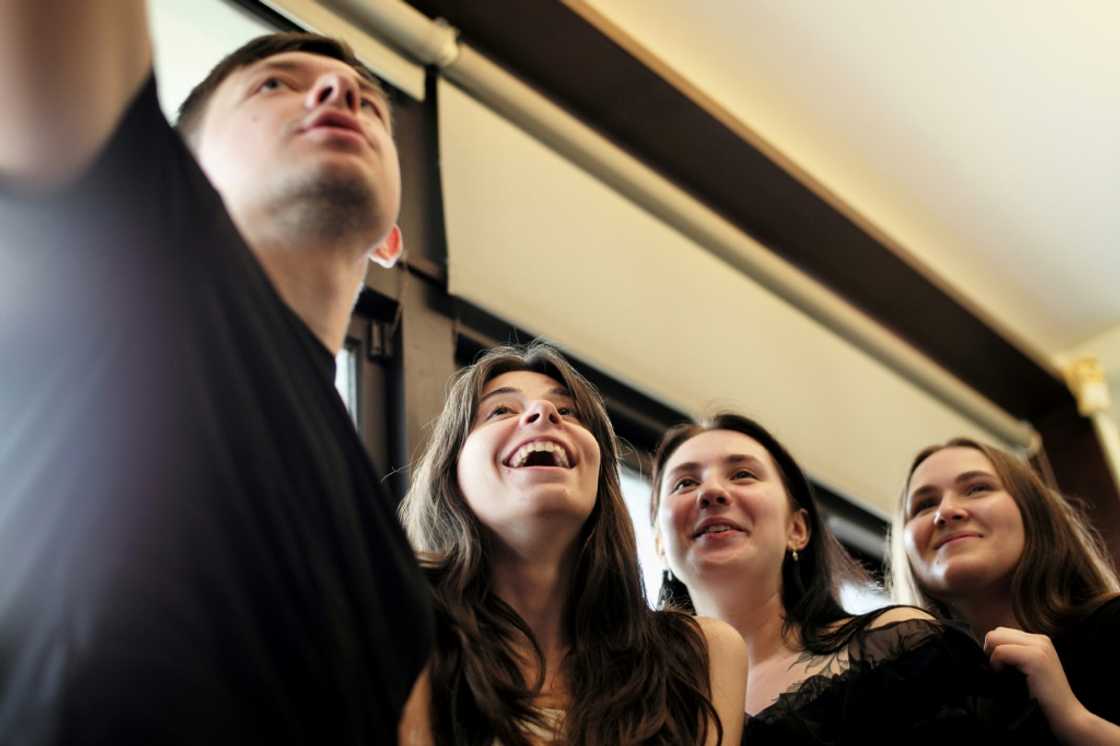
[401,345,746,746]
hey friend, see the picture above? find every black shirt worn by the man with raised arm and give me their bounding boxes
[0,73,432,745]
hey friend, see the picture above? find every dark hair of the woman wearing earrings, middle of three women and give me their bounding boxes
[650,412,869,654]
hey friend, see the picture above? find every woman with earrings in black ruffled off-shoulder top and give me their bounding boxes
[651,413,1027,746]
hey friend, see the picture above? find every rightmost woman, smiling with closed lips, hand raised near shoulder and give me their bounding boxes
[892,438,1120,745]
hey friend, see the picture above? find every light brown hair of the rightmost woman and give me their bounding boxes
[888,438,1120,636]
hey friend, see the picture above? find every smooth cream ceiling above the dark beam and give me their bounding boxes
[570,0,1120,360]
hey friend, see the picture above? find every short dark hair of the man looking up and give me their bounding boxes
[175,31,389,142]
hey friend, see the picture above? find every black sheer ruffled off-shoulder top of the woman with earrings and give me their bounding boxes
[743,618,1053,746]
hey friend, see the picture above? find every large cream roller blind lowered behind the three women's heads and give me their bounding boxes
[438,81,996,514]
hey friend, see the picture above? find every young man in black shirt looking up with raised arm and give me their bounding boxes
[0,0,431,744]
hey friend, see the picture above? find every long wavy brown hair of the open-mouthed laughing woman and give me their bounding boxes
[400,344,722,746]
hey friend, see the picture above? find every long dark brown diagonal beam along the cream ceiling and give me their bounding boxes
[410,0,1073,421]
